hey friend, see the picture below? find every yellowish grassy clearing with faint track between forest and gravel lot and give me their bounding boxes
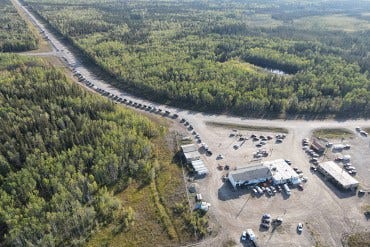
[87,130,194,246]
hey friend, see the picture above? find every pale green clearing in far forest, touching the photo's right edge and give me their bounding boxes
[294,15,370,32]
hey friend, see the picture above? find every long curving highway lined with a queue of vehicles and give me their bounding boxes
[14,0,370,132]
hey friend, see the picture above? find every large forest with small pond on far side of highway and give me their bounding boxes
[25,0,370,117]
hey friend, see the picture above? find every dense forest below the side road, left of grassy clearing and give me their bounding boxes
[0,54,160,246]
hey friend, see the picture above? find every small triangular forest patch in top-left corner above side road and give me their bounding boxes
[0,0,38,52]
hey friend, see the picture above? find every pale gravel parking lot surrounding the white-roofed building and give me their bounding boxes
[184,123,370,246]
